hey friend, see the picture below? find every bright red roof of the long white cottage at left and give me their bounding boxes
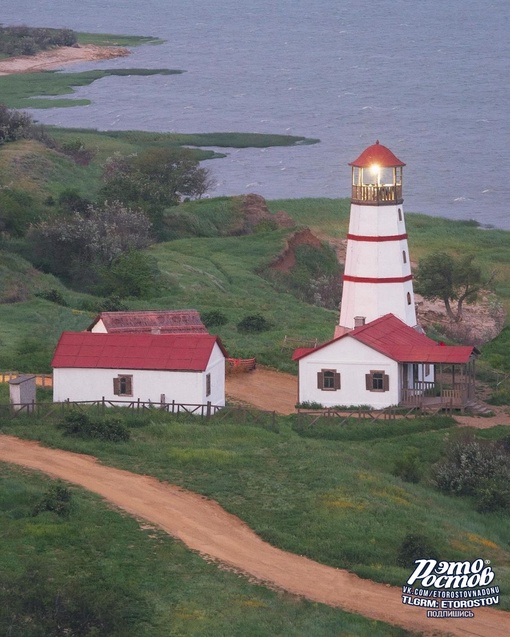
[51,332,227,371]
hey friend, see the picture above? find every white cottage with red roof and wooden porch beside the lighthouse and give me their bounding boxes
[293,314,475,409]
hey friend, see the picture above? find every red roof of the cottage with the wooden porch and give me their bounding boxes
[292,314,474,363]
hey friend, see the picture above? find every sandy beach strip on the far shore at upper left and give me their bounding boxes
[0,44,130,76]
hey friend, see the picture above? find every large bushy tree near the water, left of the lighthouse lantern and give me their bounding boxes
[101,148,211,210]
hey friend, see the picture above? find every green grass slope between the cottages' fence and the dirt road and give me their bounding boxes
[2,412,510,608]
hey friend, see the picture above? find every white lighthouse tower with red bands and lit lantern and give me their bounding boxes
[335,141,416,336]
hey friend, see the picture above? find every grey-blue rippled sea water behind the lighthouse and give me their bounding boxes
[0,0,510,229]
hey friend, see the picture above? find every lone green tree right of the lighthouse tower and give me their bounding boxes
[416,252,495,323]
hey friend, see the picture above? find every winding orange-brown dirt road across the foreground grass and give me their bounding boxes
[0,436,510,637]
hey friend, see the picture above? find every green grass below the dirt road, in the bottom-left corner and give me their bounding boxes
[0,465,409,637]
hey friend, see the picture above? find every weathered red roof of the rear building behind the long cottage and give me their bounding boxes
[87,310,207,334]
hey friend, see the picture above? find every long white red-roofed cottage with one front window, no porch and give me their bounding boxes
[52,332,227,406]
